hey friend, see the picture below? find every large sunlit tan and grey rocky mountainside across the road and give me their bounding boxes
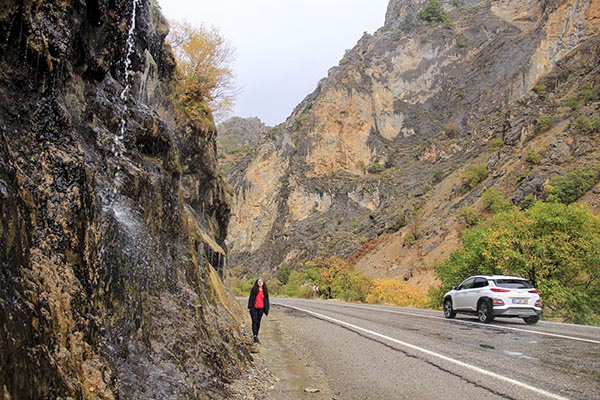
[227,0,600,285]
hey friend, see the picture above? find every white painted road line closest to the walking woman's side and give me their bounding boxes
[277,303,568,400]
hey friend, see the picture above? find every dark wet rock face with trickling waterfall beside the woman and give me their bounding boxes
[0,0,249,399]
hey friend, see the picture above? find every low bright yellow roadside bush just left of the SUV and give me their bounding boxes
[366,279,428,308]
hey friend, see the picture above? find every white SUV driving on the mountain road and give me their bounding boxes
[444,275,542,324]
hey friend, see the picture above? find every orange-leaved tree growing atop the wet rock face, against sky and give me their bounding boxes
[169,22,237,121]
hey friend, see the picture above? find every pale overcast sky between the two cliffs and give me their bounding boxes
[159,0,388,126]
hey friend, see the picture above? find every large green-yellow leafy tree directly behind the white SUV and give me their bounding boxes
[431,202,600,324]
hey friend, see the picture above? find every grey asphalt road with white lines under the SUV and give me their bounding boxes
[271,298,600,400]
